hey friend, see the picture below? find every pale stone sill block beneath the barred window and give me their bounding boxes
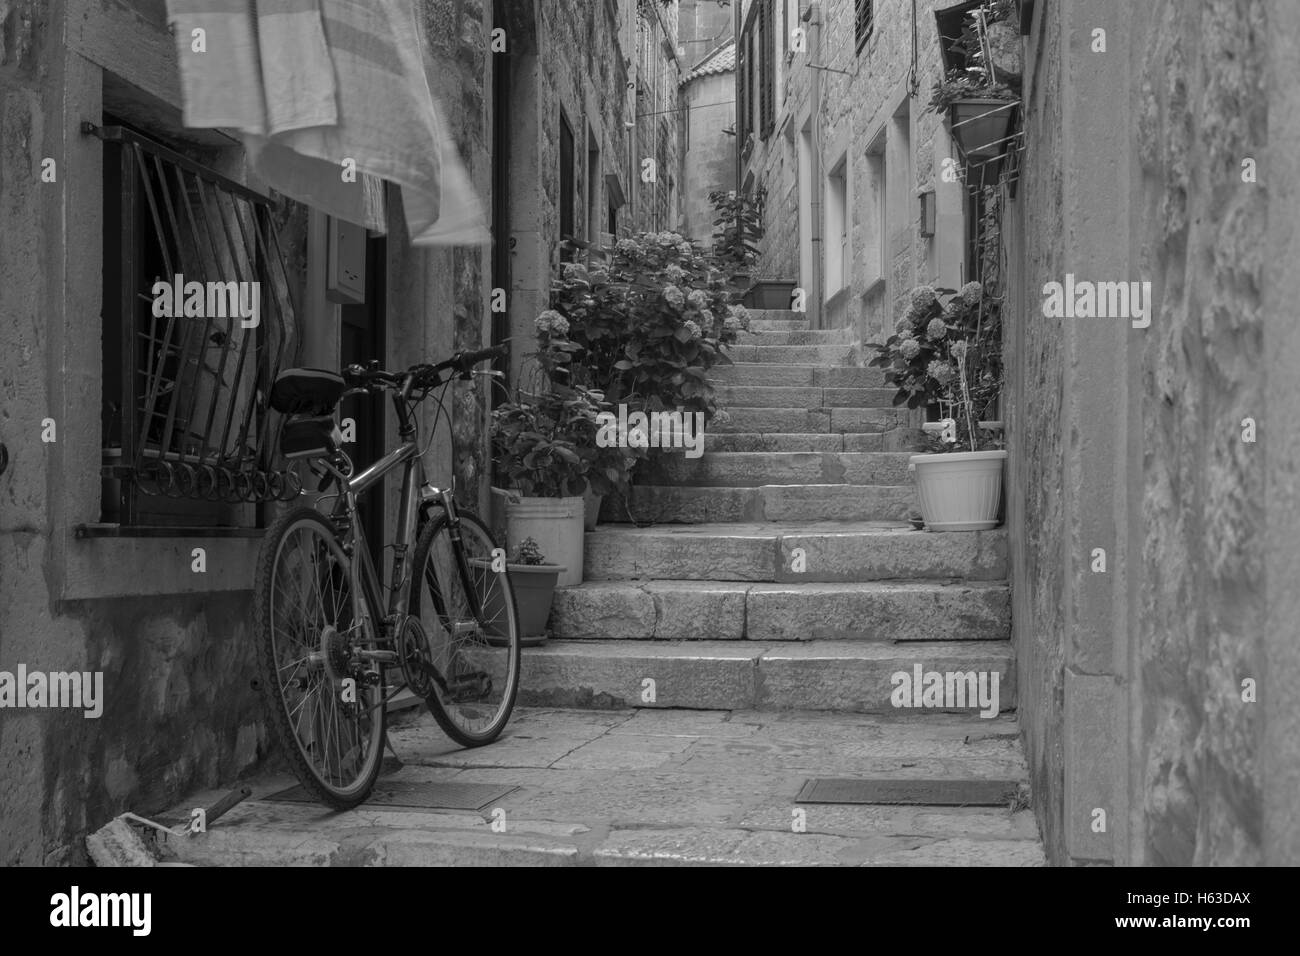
[60,525,263,601]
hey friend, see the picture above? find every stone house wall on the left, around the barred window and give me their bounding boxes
[0,0,660,864]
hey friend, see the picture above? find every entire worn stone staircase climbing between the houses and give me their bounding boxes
[520,312,1015,714]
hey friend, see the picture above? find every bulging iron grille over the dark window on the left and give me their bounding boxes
[92,124,302,533]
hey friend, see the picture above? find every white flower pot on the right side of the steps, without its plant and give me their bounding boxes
[907,449,1006,531]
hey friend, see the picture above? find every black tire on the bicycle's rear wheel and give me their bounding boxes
[254,507,386,810]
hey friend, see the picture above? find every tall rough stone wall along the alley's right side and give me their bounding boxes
[1008,0,1274,865]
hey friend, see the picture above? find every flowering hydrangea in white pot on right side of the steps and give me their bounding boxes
[868,282,1006,531]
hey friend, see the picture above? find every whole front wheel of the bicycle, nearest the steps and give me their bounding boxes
[403,511,520,747]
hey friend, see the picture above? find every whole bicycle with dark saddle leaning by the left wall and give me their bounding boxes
[254,347,520,809]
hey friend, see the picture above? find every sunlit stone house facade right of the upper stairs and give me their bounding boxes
[736,0,966,341]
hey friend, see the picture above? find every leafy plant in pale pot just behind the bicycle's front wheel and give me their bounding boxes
[491,384,602,587]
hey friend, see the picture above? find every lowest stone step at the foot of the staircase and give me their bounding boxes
[519,640,1015,717]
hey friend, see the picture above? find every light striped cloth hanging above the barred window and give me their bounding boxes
[166,0,489,246]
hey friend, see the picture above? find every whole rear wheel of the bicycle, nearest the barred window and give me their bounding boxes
[254,507,385,809]
